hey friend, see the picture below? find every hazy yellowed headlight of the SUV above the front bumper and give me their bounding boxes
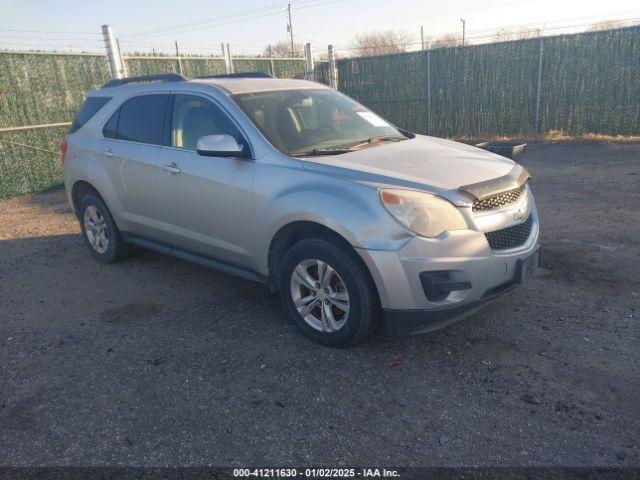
[380,188,468,237]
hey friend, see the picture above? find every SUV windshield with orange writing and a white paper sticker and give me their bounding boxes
[233,89,406,156]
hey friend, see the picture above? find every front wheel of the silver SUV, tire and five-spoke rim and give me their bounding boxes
[278,238,380,347]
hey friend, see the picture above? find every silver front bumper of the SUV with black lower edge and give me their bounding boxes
[358,197,540,335]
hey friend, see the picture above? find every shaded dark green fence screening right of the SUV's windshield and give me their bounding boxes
[316,27,640,138]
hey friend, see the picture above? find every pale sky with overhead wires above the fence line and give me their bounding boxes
[0,0,640,55]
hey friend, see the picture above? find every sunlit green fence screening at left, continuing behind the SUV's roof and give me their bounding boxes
[0,52,305,198]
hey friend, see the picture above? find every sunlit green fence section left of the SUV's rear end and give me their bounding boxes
[0,53,110,198]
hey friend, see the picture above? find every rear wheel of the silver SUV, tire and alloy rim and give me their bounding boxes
[79,193,130,263]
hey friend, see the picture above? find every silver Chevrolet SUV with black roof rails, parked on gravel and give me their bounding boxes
[61,74,539,345]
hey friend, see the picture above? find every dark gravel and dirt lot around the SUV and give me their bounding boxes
[0,145,640,467]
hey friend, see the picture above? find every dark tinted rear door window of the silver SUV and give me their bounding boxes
[115,94,169,145]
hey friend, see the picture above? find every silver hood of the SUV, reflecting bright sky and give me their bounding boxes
[303,135,515,197]
